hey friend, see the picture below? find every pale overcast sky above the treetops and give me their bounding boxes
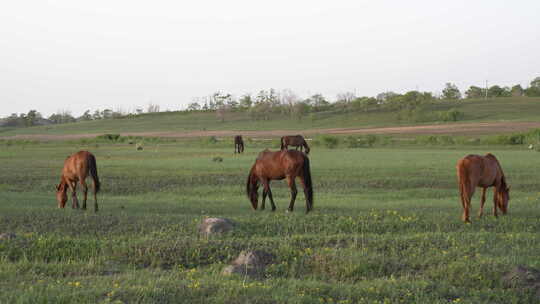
[0,0,540,116]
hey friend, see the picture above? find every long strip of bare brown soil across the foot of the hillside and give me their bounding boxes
[4,122,540,140]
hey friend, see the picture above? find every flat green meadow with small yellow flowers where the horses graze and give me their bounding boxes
[0,142,540,304]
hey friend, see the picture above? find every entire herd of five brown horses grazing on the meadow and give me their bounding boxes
[56,135,510,223]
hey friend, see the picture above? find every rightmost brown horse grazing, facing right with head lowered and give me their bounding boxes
[456,153,510,223]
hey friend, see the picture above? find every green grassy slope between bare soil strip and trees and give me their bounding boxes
[0,97,540,136]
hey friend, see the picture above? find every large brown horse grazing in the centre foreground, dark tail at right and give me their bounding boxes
[246,150,313,213]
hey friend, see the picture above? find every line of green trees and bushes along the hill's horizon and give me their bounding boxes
[4,77,540,127]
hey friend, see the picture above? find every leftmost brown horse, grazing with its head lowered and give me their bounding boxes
[56,151,101,212]
